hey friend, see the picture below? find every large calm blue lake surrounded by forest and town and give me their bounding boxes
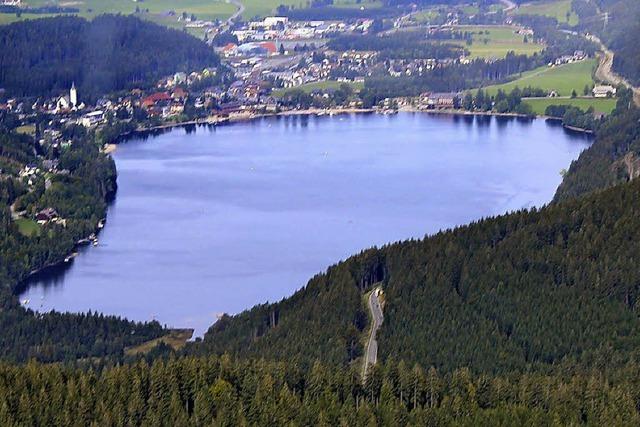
[21,113,591,335]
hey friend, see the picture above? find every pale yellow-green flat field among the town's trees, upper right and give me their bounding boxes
[456,25,544,58]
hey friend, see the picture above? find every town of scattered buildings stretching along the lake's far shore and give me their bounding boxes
[0,0,617,181]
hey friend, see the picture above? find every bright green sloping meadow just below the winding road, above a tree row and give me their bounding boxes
[486,59,596,96]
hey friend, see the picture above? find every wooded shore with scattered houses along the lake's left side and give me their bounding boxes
[0,127,165,362]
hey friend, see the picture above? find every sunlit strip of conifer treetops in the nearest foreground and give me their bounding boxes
[5,357,640,427]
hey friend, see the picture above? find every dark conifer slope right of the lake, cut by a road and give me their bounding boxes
[189,122,640,373]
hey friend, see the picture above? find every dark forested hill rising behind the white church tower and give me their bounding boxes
[0,15,219,100]
